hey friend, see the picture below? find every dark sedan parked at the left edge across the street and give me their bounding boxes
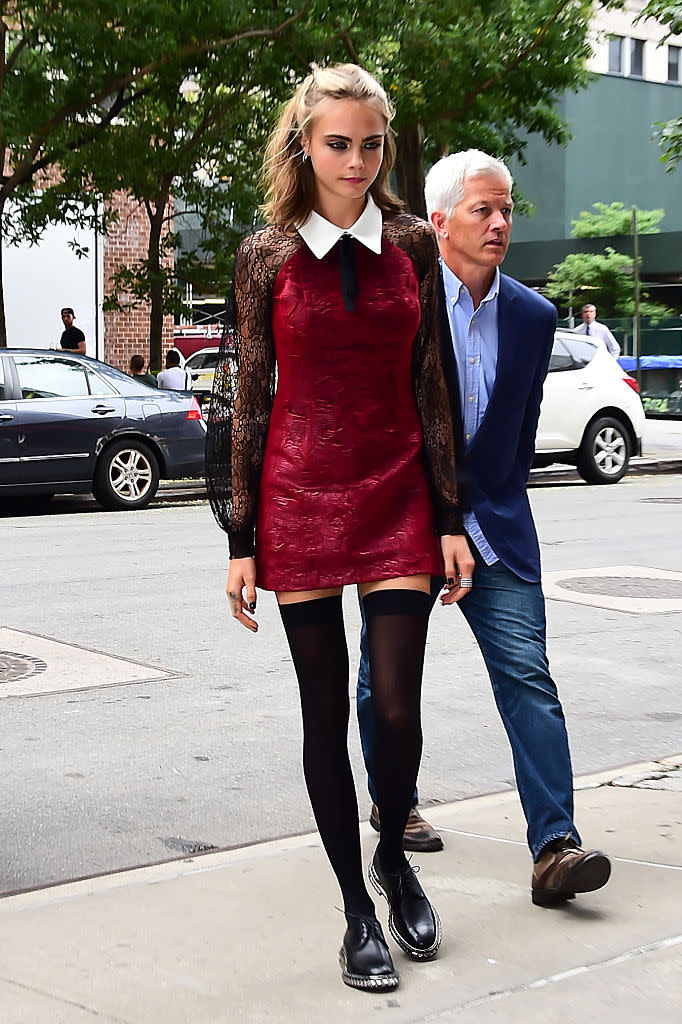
[0,348,206,509]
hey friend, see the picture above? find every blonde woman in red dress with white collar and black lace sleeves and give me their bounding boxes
[207,65,473,991]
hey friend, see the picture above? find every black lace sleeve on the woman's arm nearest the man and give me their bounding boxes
[385,214,464,536]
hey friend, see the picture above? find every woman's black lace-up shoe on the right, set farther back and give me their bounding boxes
[370,849,440,961]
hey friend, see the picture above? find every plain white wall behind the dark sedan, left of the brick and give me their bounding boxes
[2,210,104,358]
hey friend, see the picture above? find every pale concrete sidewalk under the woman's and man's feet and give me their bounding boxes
[0,757,682,1024]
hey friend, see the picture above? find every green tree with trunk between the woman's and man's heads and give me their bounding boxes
[292,0,623,216]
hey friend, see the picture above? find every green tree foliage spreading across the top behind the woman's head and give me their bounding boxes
[0,0,623,349]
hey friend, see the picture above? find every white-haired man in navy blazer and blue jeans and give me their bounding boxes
[357,150,610,906]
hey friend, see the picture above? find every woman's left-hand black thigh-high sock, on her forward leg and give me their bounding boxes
[280,596,375,916]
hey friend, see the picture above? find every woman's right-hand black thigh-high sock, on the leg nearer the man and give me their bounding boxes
[364,590,431,871]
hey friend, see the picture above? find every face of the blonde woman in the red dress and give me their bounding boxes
[301,99,385,207]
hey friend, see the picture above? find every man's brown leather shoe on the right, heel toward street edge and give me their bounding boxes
[530,842,611,906]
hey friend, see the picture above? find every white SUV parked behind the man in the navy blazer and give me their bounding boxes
[534,331,644,483]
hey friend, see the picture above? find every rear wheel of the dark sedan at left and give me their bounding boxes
[92,439,159,509]
